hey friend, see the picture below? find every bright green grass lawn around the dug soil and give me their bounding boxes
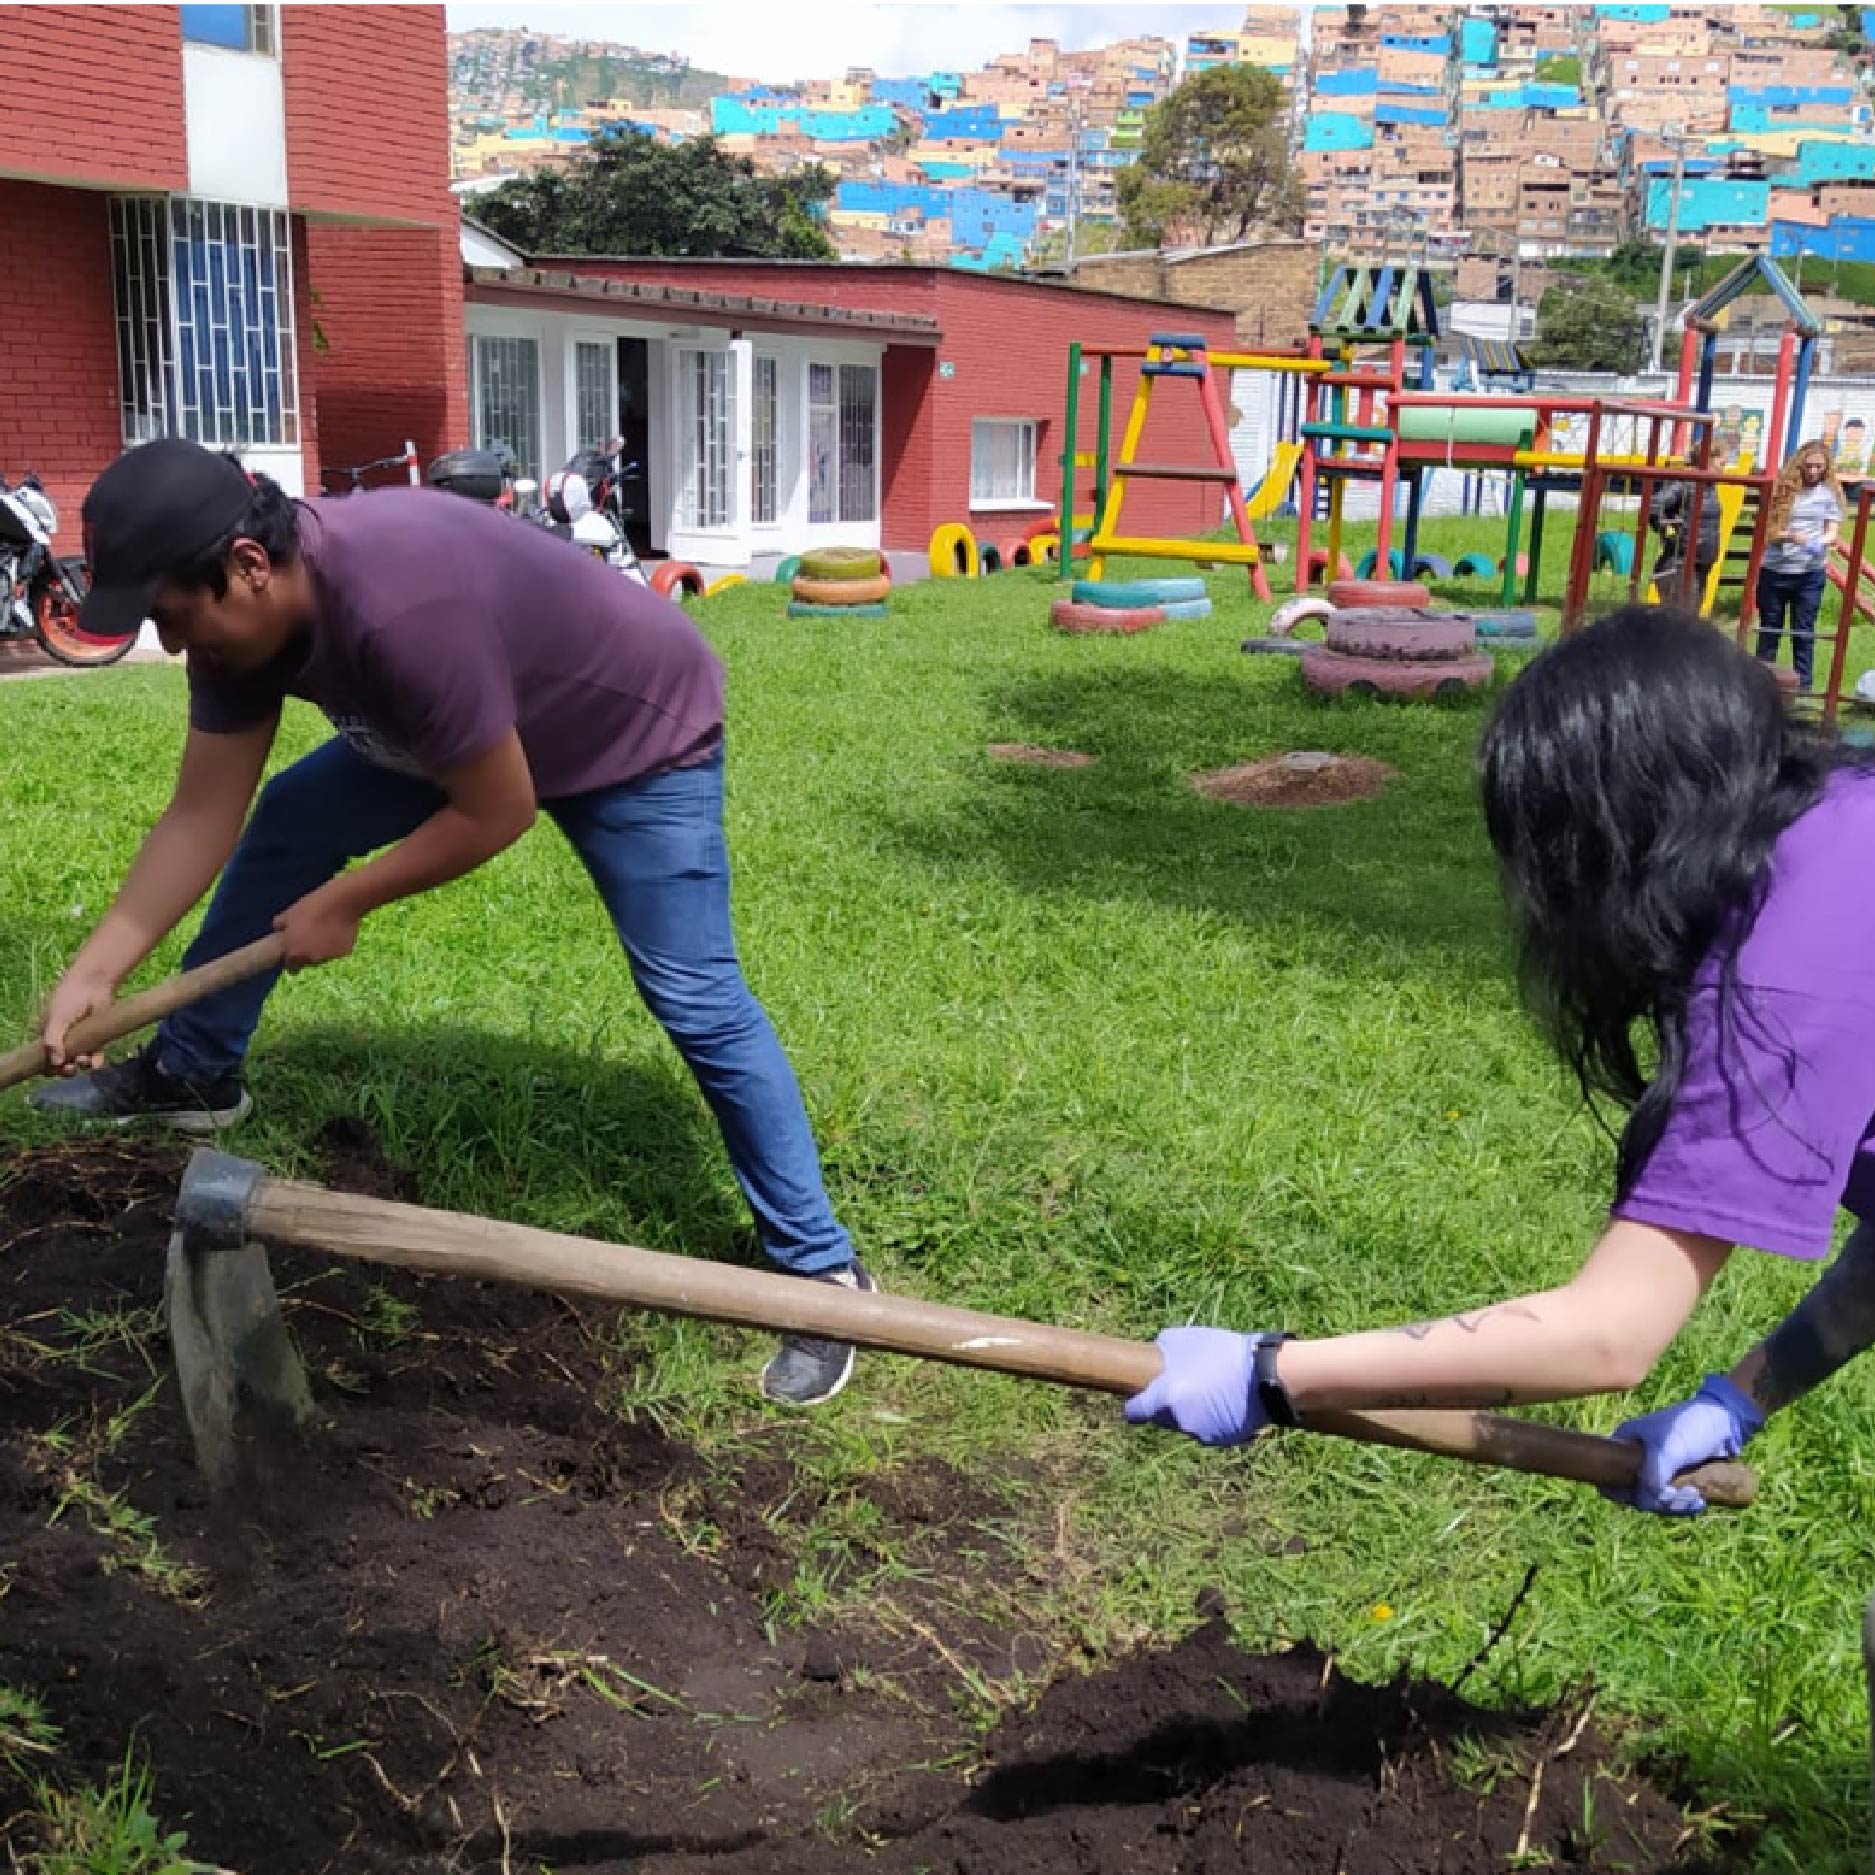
[0,525,1875,1875]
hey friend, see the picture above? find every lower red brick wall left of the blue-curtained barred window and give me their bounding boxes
[0,180,122,532]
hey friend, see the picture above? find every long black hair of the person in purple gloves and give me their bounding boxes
[1483,606,1858,1194]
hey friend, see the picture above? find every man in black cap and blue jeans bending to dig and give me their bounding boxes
[34,439,872,1406]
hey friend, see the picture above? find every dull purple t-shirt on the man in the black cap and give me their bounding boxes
[189,488,722,801]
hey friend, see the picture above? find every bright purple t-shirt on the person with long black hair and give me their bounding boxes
[1614,773,1875,1260]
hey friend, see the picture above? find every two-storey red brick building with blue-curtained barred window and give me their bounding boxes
[0,6,467,528]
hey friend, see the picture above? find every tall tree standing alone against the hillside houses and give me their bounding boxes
[1119,66,1301,248]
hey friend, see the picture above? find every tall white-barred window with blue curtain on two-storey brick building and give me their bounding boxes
[111,195,300,450]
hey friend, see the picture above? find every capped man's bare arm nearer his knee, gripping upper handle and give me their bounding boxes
[276,729,538,969]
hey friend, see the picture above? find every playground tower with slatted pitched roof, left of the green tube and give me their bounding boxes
[1296,266,1438,593]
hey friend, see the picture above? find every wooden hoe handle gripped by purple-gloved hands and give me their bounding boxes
[248,1179,1757,1509]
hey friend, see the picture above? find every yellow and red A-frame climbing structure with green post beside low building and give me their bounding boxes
[1058,332,1329,600]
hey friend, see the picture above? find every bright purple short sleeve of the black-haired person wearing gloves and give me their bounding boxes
[1614,984,1875,1260]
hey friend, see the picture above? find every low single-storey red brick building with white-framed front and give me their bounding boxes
[467,257,1236,566]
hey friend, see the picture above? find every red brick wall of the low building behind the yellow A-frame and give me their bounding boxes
[540,259,1236,549]
